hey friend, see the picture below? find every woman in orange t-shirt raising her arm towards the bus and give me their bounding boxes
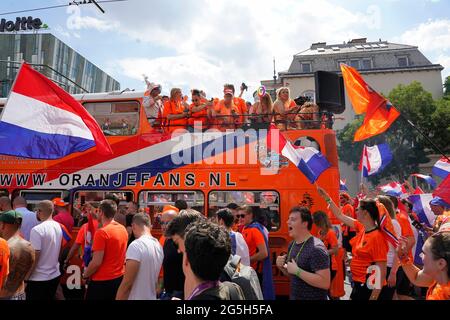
[317,187,389,300]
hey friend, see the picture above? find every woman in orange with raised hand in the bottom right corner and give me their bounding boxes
[397,229,450,300]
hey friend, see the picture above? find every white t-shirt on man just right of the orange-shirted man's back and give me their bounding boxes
[126,235,164,300]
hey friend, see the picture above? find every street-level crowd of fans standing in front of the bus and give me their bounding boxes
[0,187,450,300]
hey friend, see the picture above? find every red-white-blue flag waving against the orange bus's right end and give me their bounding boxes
[267,125,331,183]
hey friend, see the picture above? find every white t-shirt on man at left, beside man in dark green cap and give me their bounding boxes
[30,220,62,281]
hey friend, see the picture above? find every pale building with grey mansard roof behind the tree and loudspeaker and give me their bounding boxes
[262,38,444,193]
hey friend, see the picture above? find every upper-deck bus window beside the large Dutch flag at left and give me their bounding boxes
[84,101,139,136]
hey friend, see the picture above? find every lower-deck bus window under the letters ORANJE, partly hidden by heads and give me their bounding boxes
[72,190,134,226]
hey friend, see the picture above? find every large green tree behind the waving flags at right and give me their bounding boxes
[338,81,442,184]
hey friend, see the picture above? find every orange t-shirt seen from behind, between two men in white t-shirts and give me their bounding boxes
[92,221,128,281]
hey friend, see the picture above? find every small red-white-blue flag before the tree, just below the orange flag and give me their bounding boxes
[359,143,392,177]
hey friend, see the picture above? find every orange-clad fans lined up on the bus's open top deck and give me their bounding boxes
[143,81,321,133]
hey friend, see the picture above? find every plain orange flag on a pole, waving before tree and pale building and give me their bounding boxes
[341,64,400,141]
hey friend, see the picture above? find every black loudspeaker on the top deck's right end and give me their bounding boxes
[314,71,345,114]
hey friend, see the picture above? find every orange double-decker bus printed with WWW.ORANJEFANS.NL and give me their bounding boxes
[0,92,339,295]
